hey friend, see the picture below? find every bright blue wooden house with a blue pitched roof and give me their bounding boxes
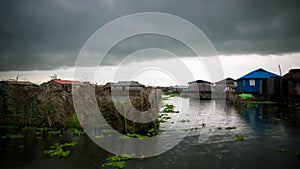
[236,68,279,94]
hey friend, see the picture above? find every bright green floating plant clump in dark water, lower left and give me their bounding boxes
[44,142,78,157]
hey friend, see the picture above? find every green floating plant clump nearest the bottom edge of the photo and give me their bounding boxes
[102,154,133,169]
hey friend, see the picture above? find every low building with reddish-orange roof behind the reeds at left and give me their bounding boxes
[42,79,82,92]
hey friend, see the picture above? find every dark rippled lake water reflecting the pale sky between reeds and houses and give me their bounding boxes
[0,97,300,169]
